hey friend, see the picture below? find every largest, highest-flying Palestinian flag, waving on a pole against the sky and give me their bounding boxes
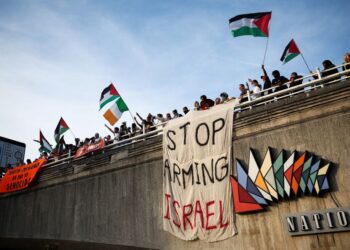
[229,12,272,37]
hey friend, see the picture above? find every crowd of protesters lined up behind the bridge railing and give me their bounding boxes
[0,53,350,177]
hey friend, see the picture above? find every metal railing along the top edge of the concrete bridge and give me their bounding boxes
[39,63,350,167]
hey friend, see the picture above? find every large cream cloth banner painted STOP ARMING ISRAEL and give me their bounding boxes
[163,103,236,242]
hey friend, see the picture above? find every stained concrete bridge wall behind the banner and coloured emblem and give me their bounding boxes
[0,82,350,250]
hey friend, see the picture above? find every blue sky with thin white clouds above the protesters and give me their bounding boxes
[0,0,350,159]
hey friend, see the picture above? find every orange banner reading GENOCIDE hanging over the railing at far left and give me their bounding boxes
[0,159,46,193]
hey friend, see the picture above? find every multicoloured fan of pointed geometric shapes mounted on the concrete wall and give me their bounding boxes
[231,148,331,213]
